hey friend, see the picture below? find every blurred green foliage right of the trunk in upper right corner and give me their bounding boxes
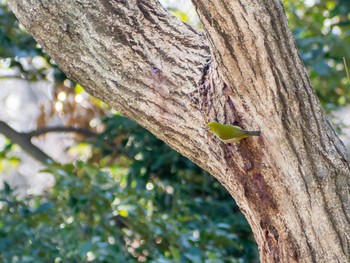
[284,0,350,110]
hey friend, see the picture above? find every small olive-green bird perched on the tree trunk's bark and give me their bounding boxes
[207,121,260,143]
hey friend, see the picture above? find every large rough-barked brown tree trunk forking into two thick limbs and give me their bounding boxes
[9,0,350,263]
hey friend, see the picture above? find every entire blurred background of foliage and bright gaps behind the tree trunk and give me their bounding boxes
[0,0,350,263]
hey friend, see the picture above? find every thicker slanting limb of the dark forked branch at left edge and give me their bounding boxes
[0,121,54,164]
